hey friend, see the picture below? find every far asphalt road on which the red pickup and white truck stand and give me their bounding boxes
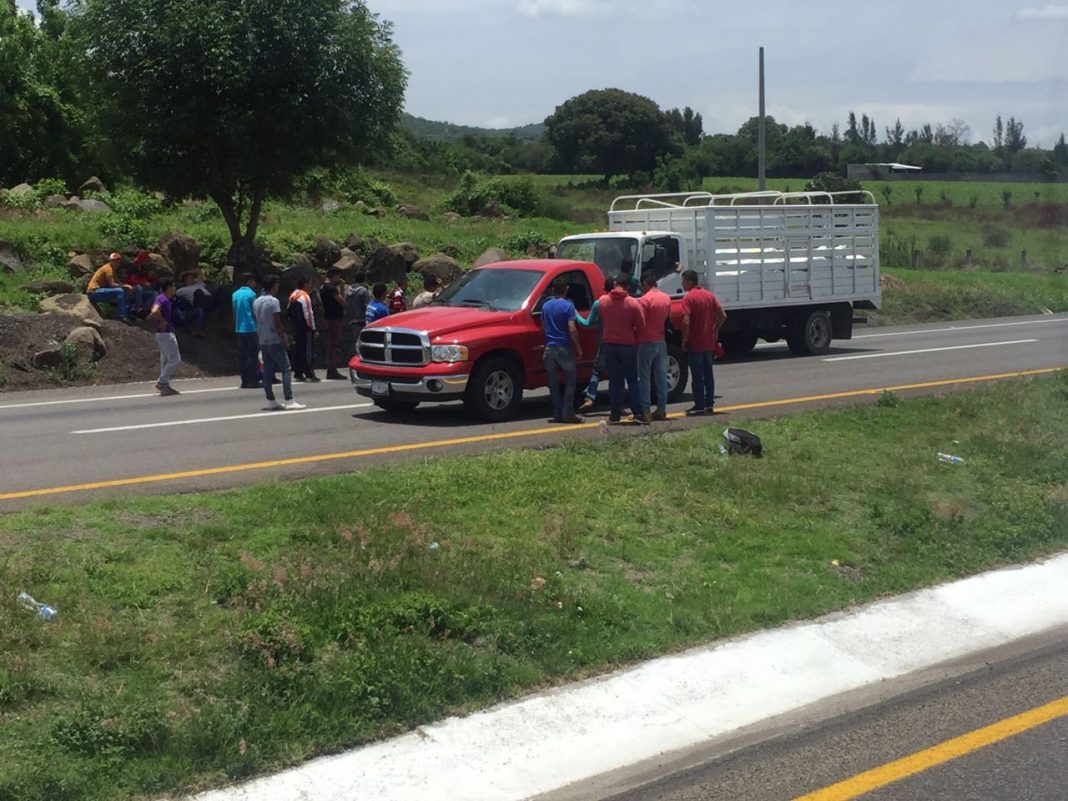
[0,315,1068,508]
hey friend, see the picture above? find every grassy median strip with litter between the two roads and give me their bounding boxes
[0,375,1068,801]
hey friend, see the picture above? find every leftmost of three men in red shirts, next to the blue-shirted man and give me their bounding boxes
[597,272,645,423]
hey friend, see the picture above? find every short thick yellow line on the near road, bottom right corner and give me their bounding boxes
[794,695,1068,801]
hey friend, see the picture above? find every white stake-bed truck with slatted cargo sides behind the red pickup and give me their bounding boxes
[556,191,881,356]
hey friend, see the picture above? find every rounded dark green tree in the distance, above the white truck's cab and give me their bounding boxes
[545,89,677,180]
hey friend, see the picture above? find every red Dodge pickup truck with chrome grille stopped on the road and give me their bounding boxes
[348,260,688,421]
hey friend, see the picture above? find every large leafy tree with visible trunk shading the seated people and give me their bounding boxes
[84,0,407,266]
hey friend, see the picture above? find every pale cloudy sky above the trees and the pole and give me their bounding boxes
[18,0,1068,146]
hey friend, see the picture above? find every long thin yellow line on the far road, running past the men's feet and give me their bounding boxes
[0,367,1062,501]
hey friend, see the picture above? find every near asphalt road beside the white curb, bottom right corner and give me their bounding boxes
[602,631,1068,801]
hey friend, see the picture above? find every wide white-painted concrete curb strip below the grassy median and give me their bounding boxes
[197,554,1068,801]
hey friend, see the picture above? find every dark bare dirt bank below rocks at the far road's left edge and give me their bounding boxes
[0,313,237,392]
